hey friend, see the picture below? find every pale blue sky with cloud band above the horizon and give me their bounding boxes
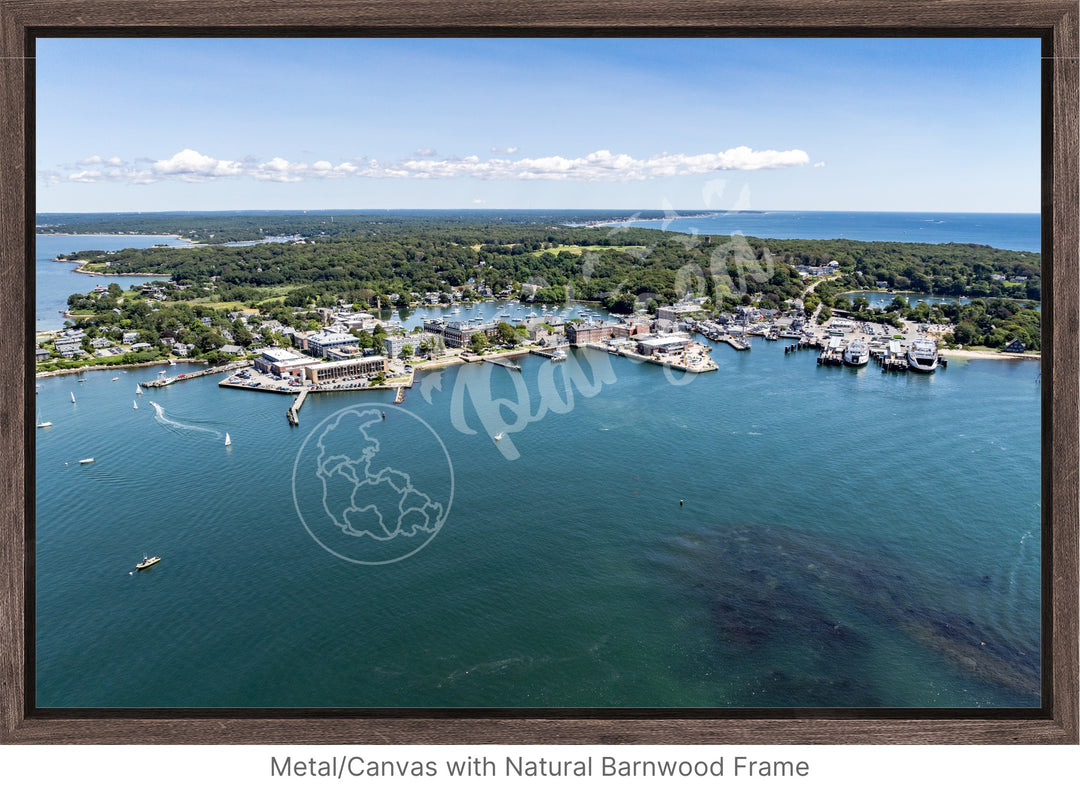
[37,39,1040,213]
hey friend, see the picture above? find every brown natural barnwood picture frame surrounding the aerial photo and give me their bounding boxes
[0,0,1080,744]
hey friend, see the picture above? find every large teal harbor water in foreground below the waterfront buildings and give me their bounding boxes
[36,340,1041,707]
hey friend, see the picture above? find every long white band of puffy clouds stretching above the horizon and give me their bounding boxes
[50,147,824,184]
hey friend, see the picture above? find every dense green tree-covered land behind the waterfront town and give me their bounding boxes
[39,212,1041,369]
